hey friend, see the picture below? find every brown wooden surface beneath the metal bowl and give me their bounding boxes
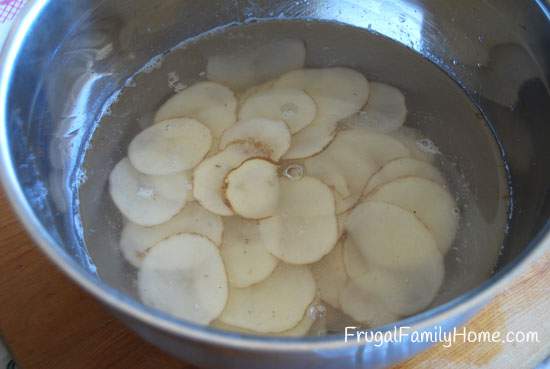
[0,192,550,369]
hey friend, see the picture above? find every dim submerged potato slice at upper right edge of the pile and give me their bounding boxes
[348,82,407,133]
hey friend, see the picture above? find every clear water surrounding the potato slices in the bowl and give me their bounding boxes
[80,20,510,334]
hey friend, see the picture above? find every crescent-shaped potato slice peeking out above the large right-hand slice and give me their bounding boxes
[364,158,445,195]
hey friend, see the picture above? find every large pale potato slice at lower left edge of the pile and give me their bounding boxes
[138,234,228,324]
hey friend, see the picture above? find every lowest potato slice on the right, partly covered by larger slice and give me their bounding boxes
[354,259,444,315]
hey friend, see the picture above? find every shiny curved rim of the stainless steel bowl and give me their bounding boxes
[0,0,550,352]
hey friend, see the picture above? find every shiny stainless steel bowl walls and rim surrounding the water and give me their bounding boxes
[0,0,550,368]
